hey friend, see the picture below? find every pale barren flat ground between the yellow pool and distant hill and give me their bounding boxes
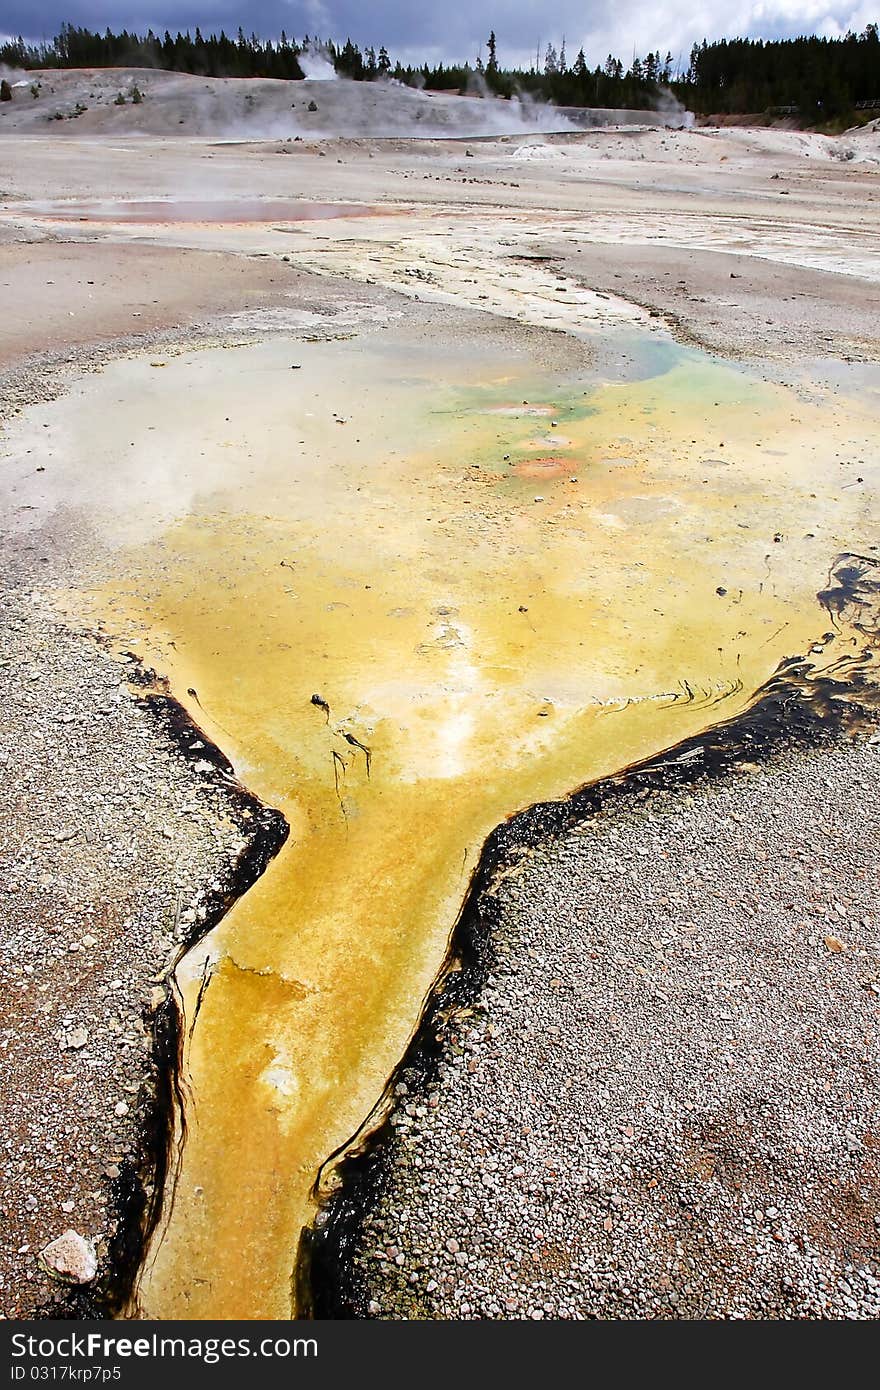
[0,82,880,363]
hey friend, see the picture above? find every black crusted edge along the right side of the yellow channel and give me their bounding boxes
[300,553,880,1319]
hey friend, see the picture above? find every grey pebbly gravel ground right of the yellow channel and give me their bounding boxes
[329,735,880,1319]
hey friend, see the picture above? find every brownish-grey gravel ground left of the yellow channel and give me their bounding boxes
[0,546,280,1318]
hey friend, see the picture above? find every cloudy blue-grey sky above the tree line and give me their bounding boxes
[0,0,880,67]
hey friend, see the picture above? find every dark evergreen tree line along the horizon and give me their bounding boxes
[0,24,880,122]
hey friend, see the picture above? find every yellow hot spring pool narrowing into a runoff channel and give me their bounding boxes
[43,329,877,1319]
